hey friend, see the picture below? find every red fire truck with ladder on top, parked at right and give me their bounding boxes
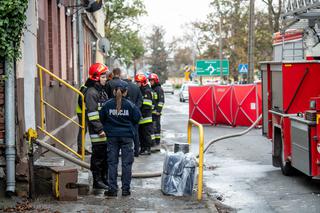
[260,0,320,177]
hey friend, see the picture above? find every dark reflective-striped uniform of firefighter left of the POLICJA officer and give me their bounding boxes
[85,83,108,188]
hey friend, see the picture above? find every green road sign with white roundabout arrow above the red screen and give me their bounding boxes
[196,59,229,76]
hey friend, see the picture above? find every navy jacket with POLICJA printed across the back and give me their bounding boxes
[100,98,141,138]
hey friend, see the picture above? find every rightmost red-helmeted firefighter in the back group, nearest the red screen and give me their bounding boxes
[149,73,164,145]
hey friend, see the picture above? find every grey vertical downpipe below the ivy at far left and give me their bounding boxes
[4,60,16,196]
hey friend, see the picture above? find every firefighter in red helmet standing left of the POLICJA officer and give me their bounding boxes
[85,63,108,189]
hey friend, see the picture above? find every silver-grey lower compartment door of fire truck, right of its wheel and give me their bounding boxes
[291,118,311,176]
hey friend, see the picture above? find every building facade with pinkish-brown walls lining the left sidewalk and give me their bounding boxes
[0,0,105,196]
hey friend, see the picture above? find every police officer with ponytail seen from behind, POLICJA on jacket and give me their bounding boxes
[100,81,141,196]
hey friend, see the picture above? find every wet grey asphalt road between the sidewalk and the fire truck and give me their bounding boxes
[162,93,320,213]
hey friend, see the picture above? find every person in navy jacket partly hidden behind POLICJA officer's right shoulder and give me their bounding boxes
[121,73,142,157]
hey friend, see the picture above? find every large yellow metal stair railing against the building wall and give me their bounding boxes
[37,64,86,160]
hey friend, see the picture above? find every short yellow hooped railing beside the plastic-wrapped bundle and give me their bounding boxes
[188,119,204,200]
